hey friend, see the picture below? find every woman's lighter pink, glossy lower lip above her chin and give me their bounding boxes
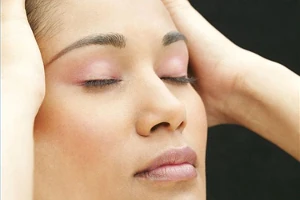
[136,163,197,181]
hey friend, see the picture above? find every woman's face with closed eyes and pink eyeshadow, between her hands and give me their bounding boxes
[34,0,207,200]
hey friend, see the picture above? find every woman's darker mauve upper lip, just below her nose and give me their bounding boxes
[135,147,197,175]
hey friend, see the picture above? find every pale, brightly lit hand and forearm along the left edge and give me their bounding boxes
[1,0,45,200]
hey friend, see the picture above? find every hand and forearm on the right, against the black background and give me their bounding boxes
[162,0,300,161]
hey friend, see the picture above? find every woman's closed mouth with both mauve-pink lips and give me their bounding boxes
[134,147,197,182]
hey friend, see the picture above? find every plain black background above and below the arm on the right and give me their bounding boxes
[190,0,300,200]
